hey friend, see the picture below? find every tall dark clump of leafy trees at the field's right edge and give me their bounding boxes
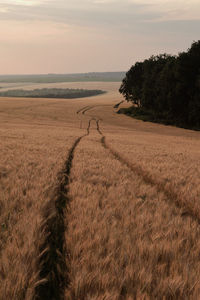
[119,40,200,129]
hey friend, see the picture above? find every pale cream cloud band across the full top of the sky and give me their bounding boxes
[0,0,200,30]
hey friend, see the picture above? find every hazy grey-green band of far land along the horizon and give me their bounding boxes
[0,72,126,83]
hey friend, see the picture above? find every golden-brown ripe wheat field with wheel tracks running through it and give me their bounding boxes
[0,82,200,300]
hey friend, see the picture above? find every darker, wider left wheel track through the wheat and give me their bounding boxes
[35,119,93,300]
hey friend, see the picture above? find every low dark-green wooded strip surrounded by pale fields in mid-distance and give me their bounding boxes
[0,88,105,99]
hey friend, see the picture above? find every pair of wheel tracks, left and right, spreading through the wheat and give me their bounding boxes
[35,113,197,300]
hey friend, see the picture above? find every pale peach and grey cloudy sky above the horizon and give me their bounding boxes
[0,0,200,74]
